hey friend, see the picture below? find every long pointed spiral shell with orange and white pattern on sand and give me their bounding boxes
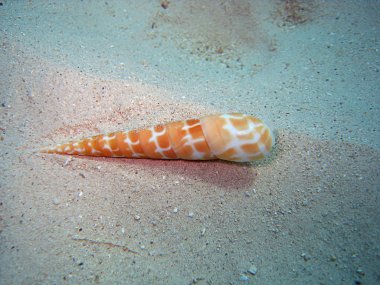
[42,113,274,162]
